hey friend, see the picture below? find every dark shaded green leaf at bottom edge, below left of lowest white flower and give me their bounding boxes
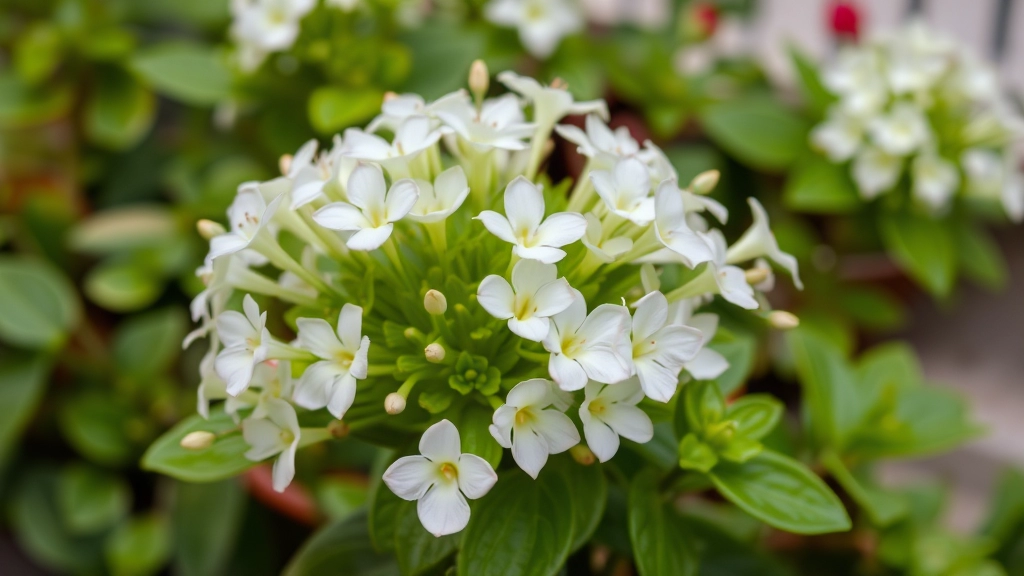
[284,512,398,576]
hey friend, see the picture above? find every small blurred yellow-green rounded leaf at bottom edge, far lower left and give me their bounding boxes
[105,515,171,576]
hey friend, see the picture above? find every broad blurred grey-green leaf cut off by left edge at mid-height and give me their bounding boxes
[0,256,82,351]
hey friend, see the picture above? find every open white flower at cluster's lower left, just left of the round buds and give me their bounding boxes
[295,303,370,420]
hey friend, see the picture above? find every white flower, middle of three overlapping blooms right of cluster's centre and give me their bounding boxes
[544,288,633,392]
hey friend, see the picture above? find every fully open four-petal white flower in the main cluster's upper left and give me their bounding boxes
[313,164,419,250]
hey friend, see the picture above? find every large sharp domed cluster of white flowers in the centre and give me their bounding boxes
[189,61,799,535]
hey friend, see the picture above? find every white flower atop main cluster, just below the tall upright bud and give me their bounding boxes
[433,90,535,150]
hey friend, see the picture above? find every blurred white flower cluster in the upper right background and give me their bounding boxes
[811,24,1024,220]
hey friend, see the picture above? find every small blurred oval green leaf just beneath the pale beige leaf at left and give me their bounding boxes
[83,260,164,313]
